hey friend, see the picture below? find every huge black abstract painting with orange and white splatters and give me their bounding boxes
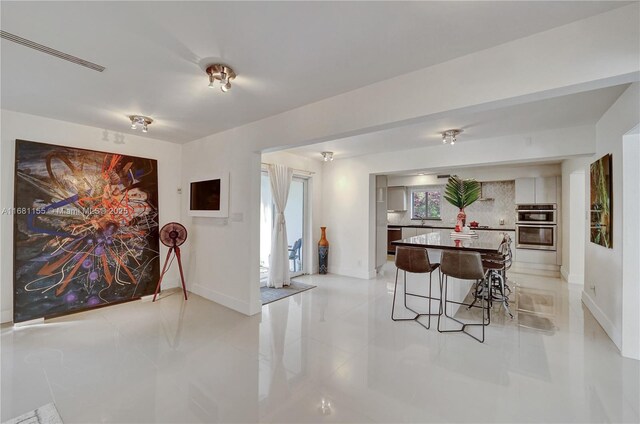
[13,140,159,322]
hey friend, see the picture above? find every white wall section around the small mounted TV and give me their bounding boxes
[182,136,262,315]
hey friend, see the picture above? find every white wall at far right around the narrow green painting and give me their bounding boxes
[582,83,640,348]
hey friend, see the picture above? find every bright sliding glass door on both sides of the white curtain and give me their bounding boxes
[260,172,308,285]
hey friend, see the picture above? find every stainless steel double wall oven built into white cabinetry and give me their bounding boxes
[516,204,558,250]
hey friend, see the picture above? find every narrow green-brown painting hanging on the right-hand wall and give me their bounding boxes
[590,154,613,248]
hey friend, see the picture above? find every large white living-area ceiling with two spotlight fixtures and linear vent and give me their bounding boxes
[1,1,628,142]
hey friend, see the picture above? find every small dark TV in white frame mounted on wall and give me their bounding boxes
[189,174,229,217]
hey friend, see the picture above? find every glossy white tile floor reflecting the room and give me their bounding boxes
[1,266,640,423]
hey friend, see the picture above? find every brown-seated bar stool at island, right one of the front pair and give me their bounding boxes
[438,250,491,343]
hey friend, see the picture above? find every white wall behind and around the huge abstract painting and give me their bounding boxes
[0,110,182,322]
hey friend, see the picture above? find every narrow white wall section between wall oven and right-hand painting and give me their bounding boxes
[560,156,591,284]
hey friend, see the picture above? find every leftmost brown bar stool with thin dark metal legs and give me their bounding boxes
[391,246,442,330]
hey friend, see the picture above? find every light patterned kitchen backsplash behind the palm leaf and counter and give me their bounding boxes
[387,181,516,228]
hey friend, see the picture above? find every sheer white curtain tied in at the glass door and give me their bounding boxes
[267,165,293,288]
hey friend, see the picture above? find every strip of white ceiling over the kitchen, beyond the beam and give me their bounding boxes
[288,84,629,160]
